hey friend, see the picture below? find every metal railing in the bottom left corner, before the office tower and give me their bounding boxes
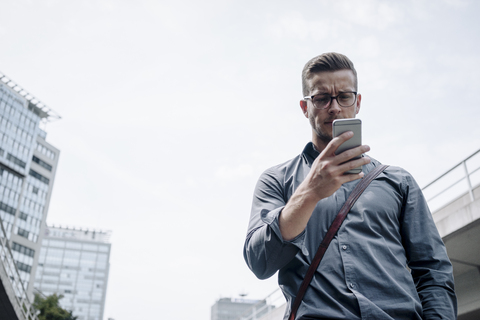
[0,220,38,320]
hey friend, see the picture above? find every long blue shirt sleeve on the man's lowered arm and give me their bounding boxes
[401,174,457,319]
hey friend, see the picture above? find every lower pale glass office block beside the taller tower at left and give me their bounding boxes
[35,226,111,320]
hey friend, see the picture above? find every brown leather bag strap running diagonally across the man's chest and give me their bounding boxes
[288,165,388,320]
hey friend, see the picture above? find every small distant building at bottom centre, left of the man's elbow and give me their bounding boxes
[210,298,269,320]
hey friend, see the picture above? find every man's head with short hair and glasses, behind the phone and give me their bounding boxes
[300,53,362,151]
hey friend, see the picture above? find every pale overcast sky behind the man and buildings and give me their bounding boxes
[0,0,480,320]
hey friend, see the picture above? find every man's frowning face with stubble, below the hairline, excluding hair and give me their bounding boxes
[300,70,362,151]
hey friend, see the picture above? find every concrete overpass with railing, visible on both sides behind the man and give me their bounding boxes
[238,150,480,320]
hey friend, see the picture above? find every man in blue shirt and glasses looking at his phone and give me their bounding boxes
[244,53,457,320]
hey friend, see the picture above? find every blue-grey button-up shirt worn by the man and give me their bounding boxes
[244,143,457,320]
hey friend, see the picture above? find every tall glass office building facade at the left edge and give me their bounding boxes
[0,74,60,298]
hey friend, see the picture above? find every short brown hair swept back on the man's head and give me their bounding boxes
[302,52,358,96]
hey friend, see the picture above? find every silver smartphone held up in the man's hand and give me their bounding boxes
[332,118,362,173]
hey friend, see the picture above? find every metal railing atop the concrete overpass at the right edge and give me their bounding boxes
[422,149,480,211]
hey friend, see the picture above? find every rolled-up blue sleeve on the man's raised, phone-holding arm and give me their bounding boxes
[243,169,305,279]
